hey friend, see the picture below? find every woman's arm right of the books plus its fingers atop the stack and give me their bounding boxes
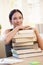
[25,26,43,50]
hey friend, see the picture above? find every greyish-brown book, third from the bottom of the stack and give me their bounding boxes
[13,43,38,50]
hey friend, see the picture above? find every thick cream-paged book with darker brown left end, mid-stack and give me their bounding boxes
[12,37,37,43]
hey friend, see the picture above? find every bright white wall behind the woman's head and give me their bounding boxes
[0,0,43,30]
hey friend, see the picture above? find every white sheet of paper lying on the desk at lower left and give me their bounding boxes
[0,58,24,64]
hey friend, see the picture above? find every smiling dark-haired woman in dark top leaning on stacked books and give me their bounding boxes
[5,9,43,57]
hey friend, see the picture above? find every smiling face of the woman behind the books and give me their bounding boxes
[11,12,23,27]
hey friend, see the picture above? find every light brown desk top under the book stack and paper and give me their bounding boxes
[0,56,43,65]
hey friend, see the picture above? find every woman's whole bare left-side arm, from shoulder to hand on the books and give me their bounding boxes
[5,26,25,44]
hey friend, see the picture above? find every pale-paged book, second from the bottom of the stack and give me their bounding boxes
[16,48,42,55]
